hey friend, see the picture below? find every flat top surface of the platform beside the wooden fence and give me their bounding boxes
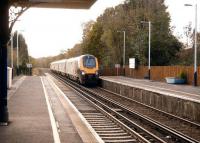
[100,76,200,103]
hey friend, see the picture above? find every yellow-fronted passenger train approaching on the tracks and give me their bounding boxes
[50,54,99,85]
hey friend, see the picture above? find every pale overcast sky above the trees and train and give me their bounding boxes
[14,0,200,58]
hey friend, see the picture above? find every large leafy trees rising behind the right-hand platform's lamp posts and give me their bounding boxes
[82,0,182,65]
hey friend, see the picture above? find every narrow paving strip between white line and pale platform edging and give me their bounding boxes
[41,76,83,143]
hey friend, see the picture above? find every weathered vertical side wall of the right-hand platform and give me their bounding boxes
[101,80,200,122]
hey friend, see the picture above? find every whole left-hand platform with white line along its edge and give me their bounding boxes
[0,76,98,143]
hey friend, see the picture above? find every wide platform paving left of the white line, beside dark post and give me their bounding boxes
[0,77,53,143]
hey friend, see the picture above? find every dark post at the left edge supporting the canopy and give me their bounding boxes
[0,0,9,125]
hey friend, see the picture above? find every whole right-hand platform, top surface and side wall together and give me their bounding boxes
[100,76,200,122]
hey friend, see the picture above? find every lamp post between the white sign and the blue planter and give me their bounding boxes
[141,21,151,80]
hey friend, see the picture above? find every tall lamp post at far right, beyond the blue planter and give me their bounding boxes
[185,3,197,86]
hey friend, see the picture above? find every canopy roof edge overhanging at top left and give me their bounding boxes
[9,0,96,9]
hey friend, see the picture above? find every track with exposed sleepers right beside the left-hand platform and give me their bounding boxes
[58,84,141,143]
